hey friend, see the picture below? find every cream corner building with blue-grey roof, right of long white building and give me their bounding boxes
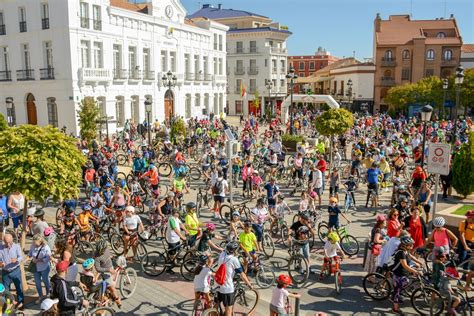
[189,4,291,115]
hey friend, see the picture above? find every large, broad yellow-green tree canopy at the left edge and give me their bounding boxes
[0,125,85,201]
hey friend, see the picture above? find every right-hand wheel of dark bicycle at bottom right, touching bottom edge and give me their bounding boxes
[410,287,445,315]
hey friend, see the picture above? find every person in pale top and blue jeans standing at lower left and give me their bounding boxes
[28,234,51,304]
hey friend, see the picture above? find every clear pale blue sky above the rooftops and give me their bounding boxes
[136,0,474,59]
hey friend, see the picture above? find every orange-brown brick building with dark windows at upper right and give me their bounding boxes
[374,14,462,110]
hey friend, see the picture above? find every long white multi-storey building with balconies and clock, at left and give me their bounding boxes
[0,0,228,134]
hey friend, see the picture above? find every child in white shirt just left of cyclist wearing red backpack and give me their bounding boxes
[194,255,214,309]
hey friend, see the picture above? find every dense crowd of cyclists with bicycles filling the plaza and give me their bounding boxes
[0,110,474,315]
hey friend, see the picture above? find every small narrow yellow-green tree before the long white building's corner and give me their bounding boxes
[77,98,100,144]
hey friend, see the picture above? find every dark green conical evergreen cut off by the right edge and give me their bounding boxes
[452,132,474,198]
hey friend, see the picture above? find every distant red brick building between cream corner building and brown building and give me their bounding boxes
[288,47,339,93]
